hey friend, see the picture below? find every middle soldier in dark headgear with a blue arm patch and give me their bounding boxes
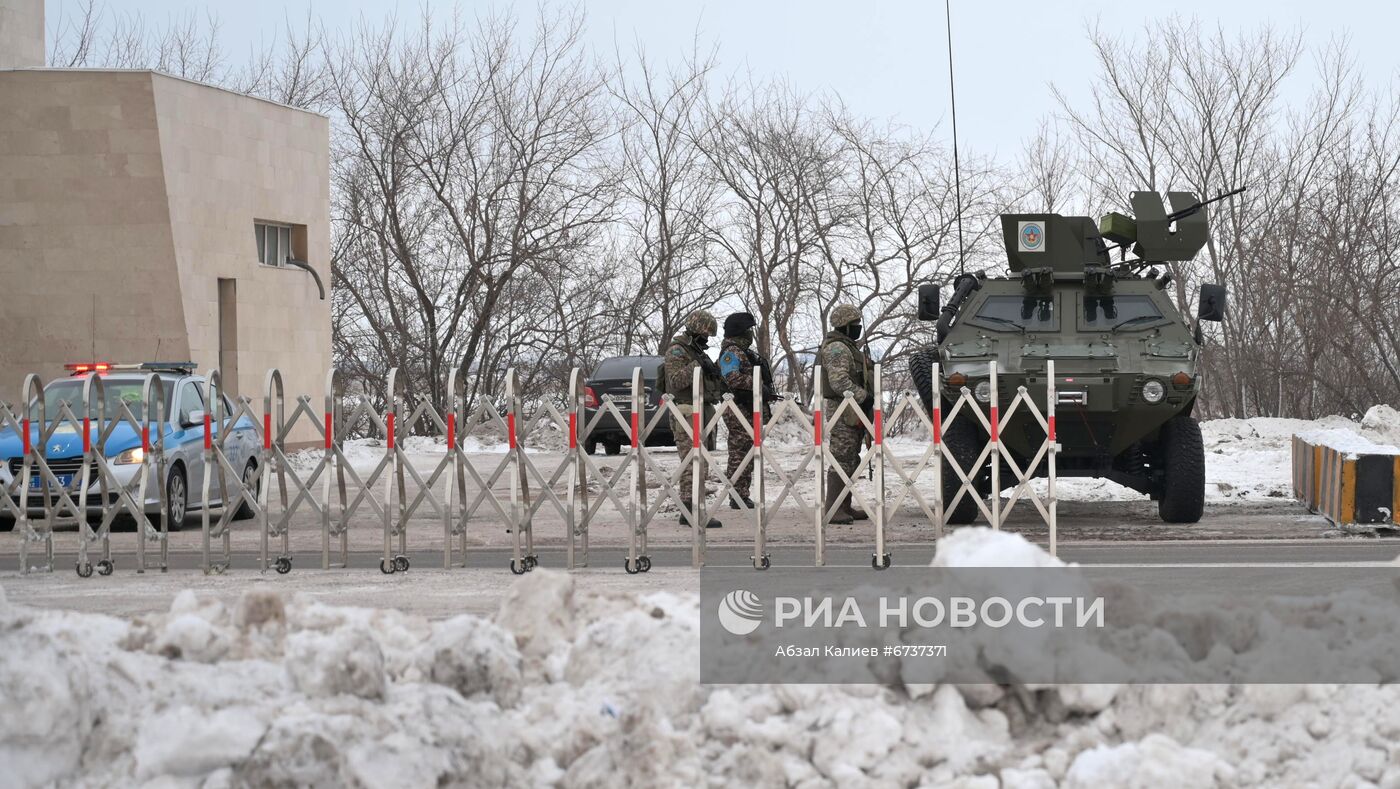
[720,312,777,509]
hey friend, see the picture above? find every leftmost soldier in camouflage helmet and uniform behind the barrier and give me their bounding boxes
[662,309,725,529]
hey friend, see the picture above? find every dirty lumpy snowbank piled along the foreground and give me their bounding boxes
[0,529,1400,788]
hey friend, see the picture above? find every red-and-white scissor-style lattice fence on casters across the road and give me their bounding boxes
[0,362,1057,575]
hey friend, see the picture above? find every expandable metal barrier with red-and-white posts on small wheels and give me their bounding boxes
[0,361,1058,576]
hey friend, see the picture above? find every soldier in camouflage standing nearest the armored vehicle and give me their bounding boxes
[816,304,875,523]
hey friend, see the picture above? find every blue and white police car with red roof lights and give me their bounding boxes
[0,362,260,532]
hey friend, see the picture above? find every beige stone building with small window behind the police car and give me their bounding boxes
[0,0,330,442]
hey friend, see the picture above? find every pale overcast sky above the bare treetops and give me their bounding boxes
[48,0,1400,158]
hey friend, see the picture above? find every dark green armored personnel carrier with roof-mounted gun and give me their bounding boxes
[910,190,1239,523]
